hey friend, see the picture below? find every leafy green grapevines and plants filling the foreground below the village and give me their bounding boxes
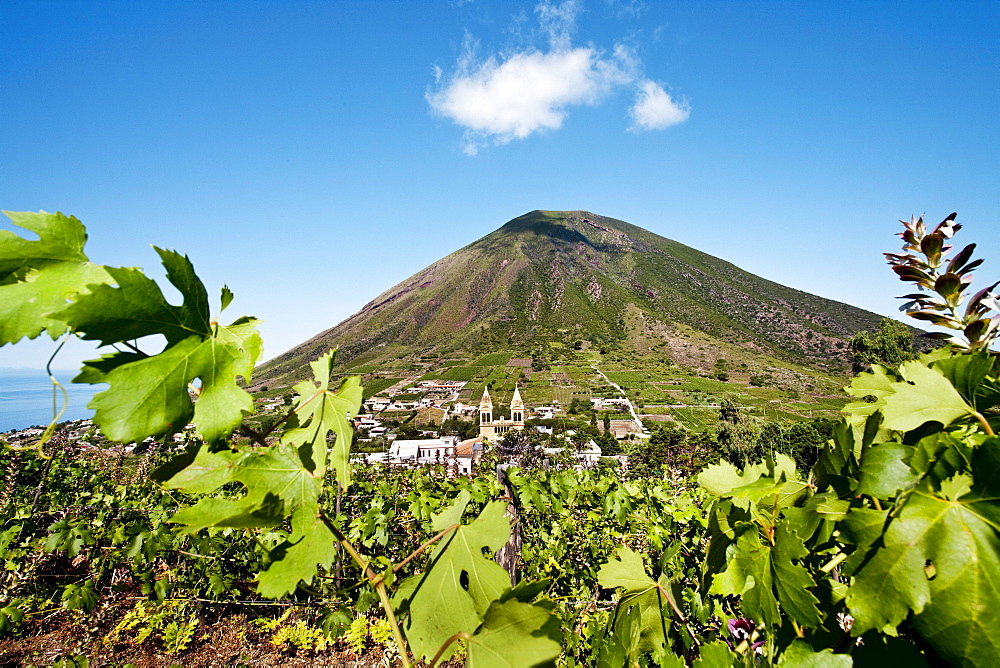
[0,213,1000,668]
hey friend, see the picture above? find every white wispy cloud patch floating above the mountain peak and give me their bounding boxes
[426,0,688,155]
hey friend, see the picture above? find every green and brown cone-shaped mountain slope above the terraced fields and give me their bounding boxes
[258,211,879,380]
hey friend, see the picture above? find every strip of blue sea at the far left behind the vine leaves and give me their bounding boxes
[0,369,108,432]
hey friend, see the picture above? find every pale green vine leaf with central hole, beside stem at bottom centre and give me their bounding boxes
[395,491,510,658]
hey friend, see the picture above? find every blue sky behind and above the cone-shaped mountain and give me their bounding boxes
[0,0,1000,367]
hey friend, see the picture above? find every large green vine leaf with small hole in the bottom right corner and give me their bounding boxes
[847,439,1000,665]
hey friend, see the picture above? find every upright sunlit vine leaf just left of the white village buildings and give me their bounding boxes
[281,351,363,489]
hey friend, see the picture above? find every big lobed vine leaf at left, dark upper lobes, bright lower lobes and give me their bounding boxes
[47,240,262,443]
